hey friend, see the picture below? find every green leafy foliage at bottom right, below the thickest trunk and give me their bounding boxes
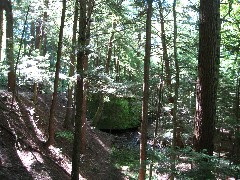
[144,147,240,179]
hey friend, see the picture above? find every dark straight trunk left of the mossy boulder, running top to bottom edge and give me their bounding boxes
[71,0,87,180]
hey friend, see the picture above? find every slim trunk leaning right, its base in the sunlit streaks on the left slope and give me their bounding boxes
[46,0,66,146]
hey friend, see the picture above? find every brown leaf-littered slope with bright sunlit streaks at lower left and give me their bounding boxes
[0,90,124,180]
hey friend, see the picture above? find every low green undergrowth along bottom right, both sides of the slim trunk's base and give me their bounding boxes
[111,147,240,179]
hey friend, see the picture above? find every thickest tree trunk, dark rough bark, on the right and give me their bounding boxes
[194,0,220,155]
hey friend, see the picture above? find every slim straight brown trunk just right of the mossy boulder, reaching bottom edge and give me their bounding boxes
[138,0,152,180]
